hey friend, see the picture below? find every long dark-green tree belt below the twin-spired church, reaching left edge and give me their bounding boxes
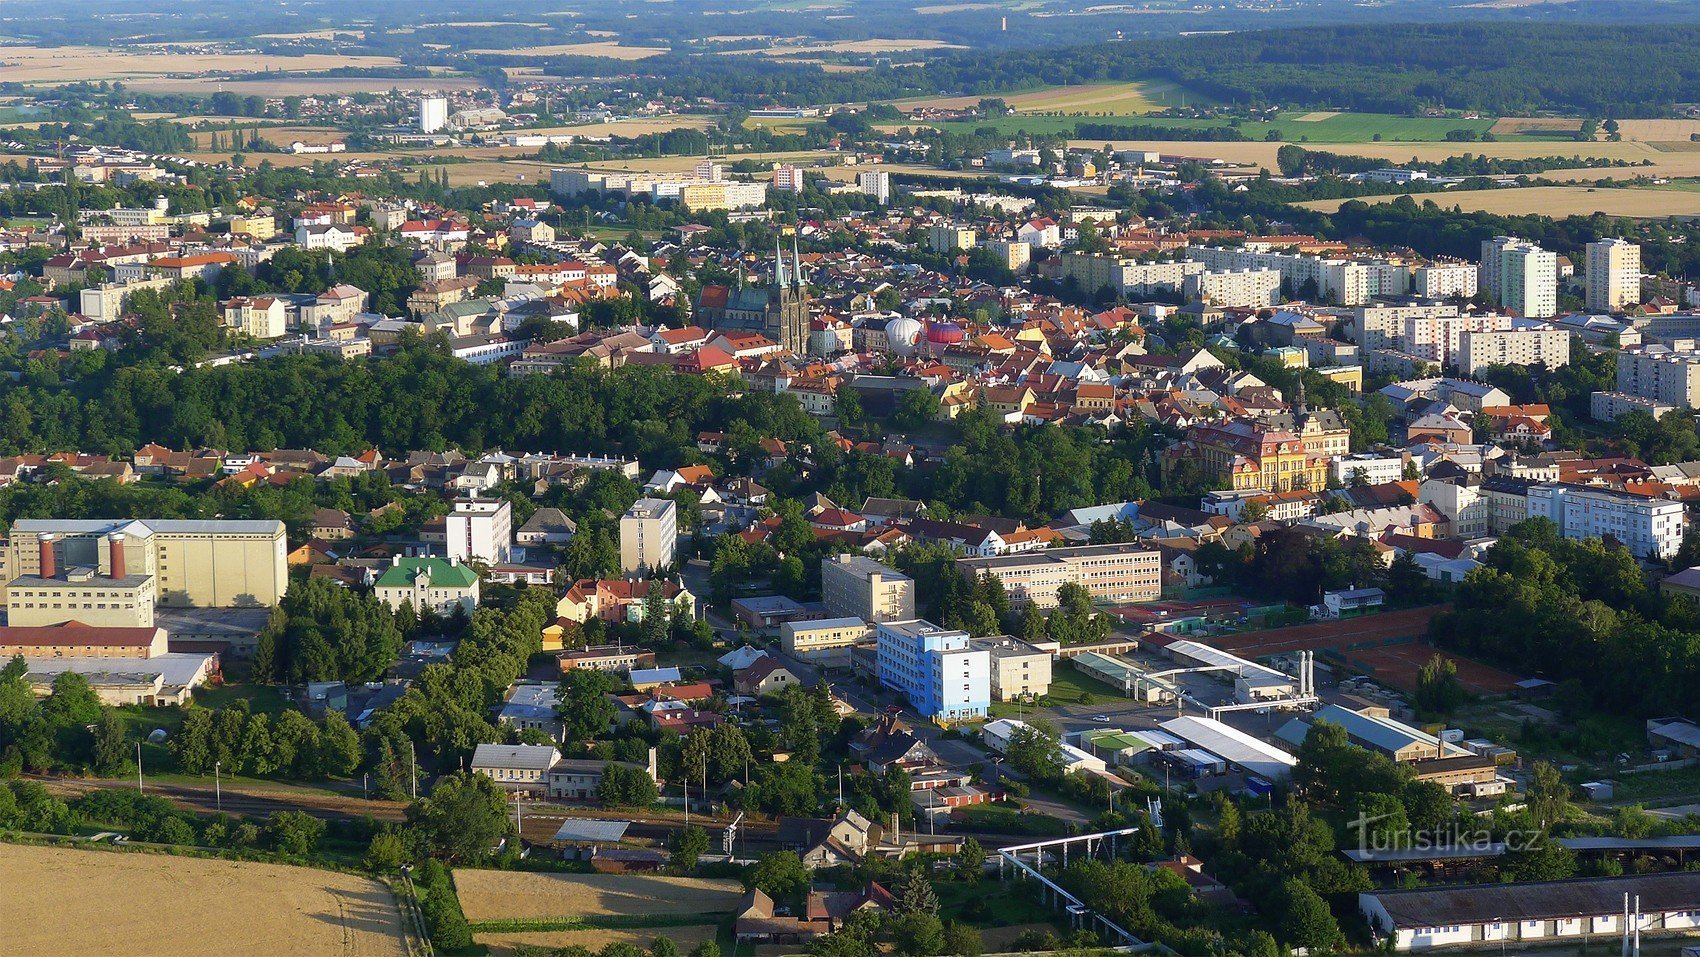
[0,340,819,464]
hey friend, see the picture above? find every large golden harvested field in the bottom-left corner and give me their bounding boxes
[0,845,408,957]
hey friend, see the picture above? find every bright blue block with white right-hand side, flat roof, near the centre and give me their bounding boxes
[874,619,991,722]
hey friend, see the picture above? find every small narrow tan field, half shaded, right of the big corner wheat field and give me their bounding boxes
[454,870,743,923]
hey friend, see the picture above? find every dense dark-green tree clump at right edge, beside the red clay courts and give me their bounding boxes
[1430,518,1700,717]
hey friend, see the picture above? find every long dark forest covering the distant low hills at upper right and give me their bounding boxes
[544,22,1700,117]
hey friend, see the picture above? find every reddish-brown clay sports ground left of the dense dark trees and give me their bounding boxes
[1202,605,1518,695]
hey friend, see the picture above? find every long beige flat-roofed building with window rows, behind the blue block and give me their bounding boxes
[957,544,1163,609]
